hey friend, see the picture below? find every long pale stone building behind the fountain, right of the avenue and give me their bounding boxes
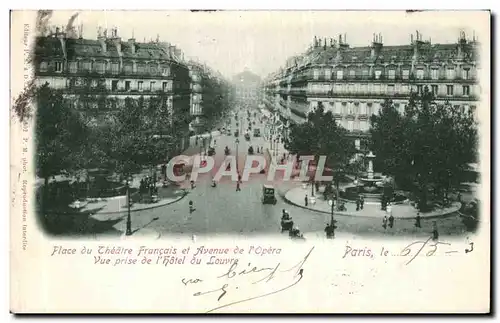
[264,32,480,149]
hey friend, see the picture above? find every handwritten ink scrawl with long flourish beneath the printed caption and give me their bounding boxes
[181,247,314,313]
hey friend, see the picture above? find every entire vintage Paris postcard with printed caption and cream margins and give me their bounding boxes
[10,10,491,314]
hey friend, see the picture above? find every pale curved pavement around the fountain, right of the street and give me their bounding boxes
[284,187,461,219]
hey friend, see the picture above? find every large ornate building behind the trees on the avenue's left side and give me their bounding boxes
[34,28,191,151]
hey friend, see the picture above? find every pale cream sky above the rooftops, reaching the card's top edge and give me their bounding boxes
[41,10,490,79]
